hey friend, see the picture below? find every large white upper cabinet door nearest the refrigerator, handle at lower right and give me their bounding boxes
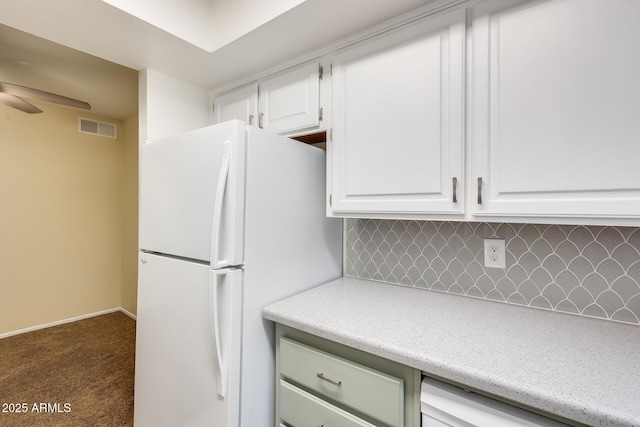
[328,10,465,218]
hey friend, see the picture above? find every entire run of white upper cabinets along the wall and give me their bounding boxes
[210,0,640,226]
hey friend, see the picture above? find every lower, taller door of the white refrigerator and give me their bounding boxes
[134,253,242,427]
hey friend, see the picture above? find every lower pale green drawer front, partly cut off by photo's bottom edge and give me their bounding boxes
[280,380,374,427]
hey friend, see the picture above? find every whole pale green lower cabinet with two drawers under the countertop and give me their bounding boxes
[276,324,420,427]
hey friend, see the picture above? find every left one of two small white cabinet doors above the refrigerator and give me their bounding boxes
[213,83,258,125]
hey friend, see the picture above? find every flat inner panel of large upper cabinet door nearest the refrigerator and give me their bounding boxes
[342,34,446,196]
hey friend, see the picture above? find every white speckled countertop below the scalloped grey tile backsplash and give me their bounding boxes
[264,278,640,426]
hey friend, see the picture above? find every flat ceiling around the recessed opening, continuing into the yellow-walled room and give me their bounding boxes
[0,0,434,119]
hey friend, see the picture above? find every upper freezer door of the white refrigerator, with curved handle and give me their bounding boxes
[139,120,246,267]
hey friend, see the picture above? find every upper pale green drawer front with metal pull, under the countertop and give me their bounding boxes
[280,337,404,427]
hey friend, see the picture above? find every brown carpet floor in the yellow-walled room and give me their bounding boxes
[0,312,136,427]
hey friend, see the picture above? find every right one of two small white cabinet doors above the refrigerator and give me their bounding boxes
[259,62,320,134]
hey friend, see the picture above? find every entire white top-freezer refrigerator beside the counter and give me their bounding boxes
[134,120,342,427]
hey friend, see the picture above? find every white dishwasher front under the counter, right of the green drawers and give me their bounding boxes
[420,377,567,427]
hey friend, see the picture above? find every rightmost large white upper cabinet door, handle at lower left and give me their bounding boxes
[469,0,640,224]
